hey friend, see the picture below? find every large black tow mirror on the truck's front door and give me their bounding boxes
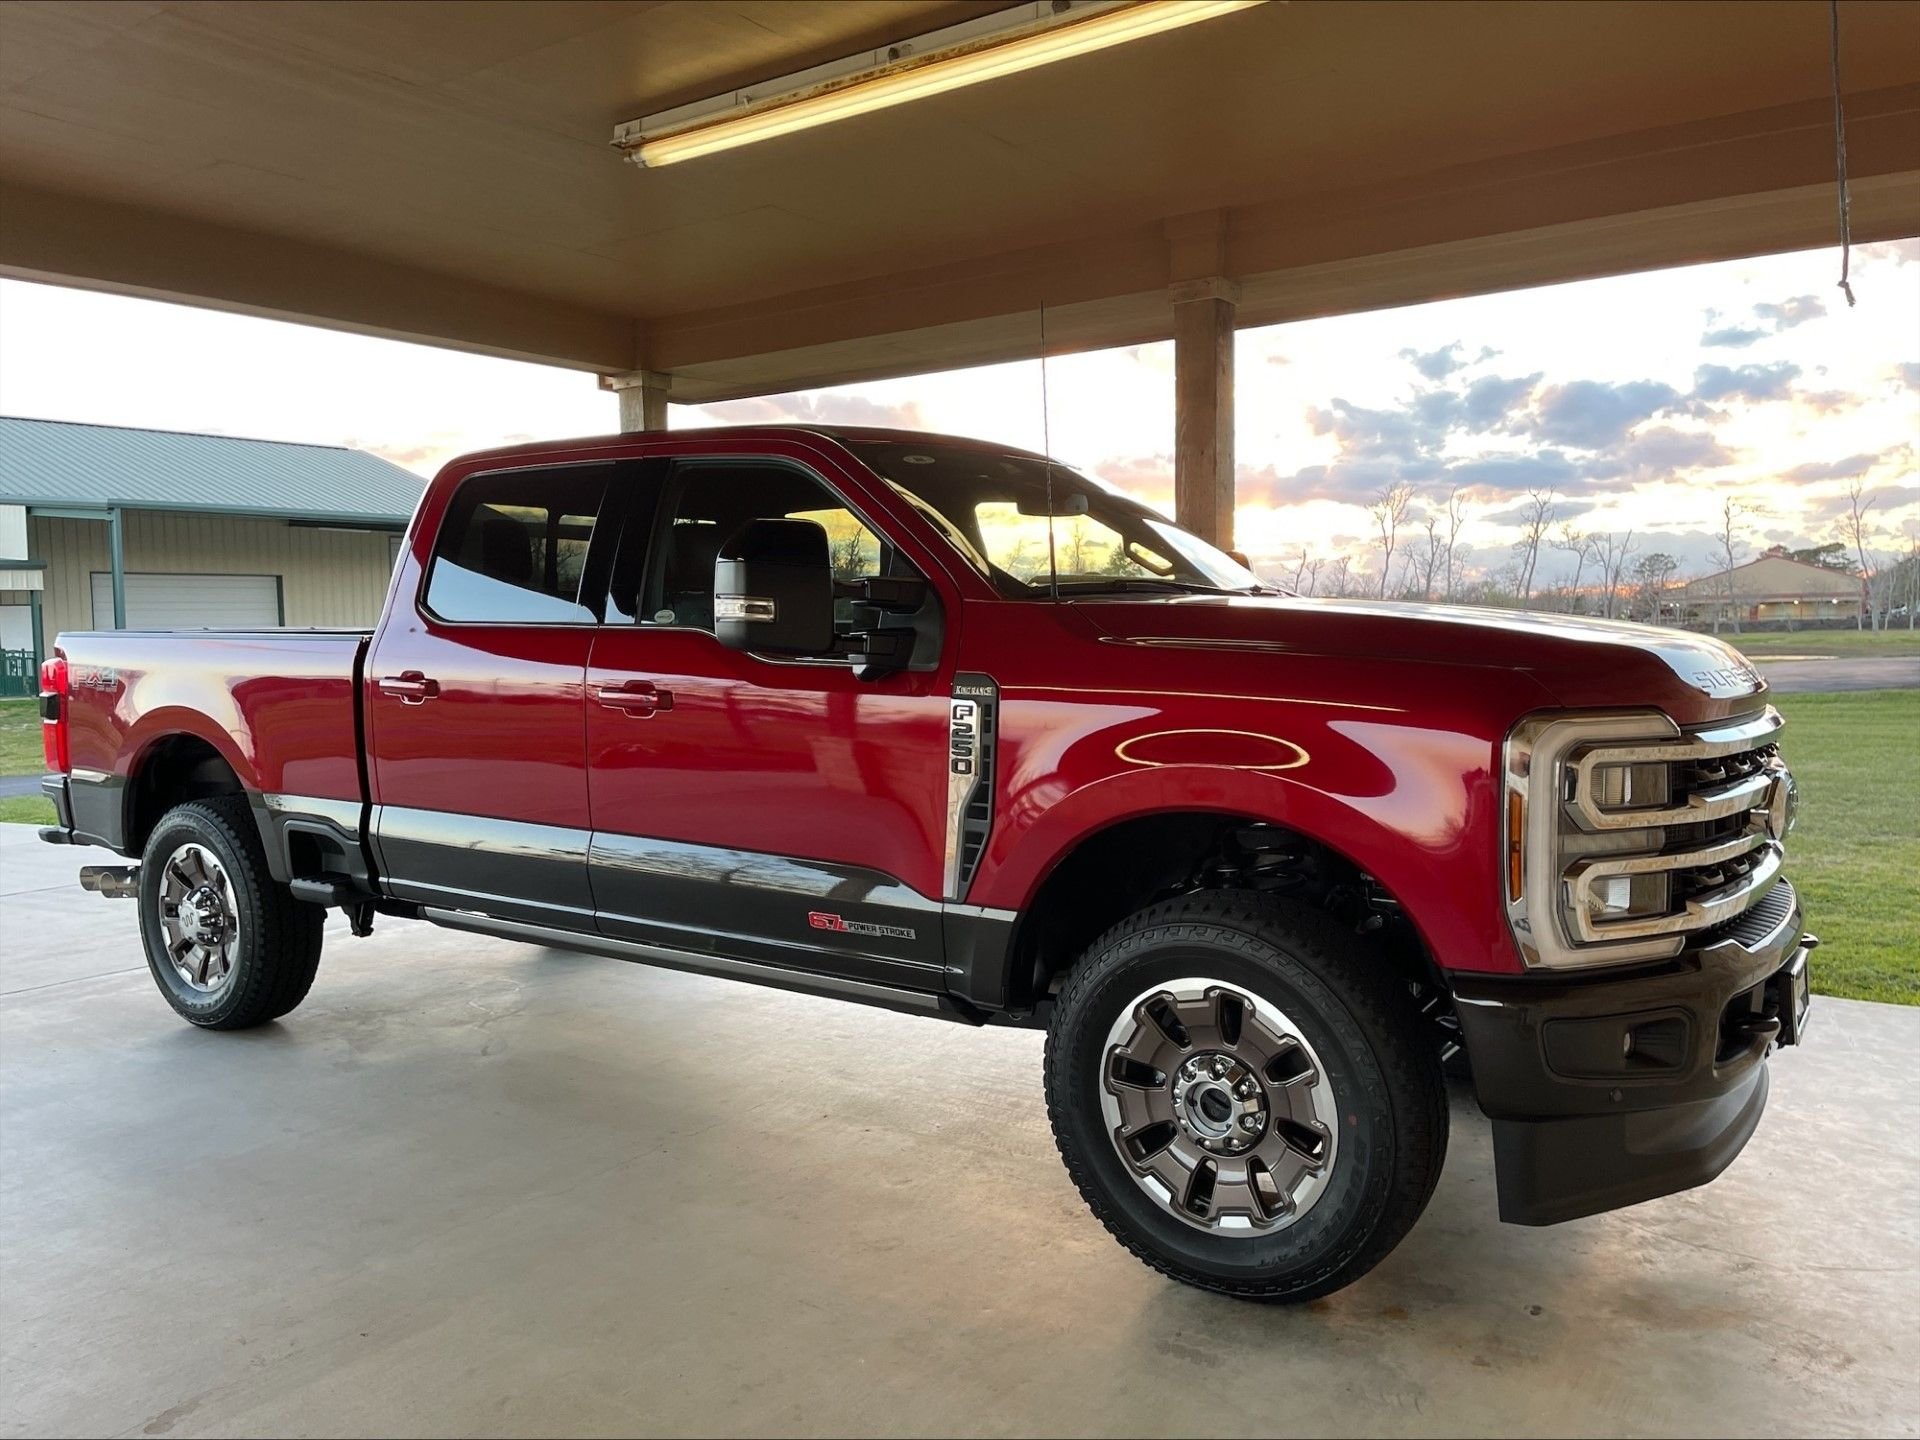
[714,520,833,655]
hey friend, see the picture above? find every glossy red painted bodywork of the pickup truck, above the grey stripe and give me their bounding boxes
[56,426,1764,973]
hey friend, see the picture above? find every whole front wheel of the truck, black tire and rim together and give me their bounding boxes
[1046,891,1448,1300]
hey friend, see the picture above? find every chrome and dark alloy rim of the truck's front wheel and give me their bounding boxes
[1100,979,1338,1235]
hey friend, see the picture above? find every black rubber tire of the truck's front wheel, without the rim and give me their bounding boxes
[1046,891,1448,1302]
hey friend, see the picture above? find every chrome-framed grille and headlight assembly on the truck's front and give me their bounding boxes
[1501,707,1795,968]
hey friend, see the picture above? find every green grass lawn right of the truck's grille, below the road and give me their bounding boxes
[1774,689,1920,1004]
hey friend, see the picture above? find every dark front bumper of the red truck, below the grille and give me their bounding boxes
[1453,881,1818,1225]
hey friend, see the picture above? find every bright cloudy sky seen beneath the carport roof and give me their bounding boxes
[0,240,1920,584]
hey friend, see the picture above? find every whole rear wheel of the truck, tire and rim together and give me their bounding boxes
[140,797,326,1029]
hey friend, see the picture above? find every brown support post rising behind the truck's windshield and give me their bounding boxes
[1173,280,1238,549]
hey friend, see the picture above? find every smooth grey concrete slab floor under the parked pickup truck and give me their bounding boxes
[0,826,1920,1436]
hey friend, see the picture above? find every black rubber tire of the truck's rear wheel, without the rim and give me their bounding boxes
[140,795,326,1029]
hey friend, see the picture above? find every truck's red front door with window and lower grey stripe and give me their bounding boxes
[586,459,952,991]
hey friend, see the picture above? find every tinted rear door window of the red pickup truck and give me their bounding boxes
[426,465,611,624]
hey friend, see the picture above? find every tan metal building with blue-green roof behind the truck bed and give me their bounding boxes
[0,417,424,693]
